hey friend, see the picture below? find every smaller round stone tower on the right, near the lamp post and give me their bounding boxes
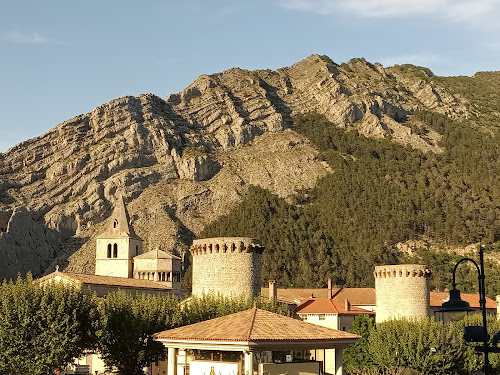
[374,264,431,323]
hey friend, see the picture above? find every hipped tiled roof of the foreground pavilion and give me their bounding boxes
[154,307,359,342]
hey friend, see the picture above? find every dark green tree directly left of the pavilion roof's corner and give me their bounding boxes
[97,290,181,375]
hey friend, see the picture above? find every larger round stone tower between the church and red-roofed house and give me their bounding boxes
[190,237,264,297]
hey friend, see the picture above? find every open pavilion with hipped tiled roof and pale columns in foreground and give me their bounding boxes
[154,307,360,375]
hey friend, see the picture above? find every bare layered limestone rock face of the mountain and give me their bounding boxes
[0,55,469,278]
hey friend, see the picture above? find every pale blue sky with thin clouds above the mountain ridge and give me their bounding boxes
[0,0,500,152]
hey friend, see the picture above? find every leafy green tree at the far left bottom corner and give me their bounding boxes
[0,274,97,375]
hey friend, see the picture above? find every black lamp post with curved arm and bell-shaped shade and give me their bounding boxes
[438,242,489,375]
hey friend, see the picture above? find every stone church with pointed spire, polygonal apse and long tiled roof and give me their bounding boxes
[39,196,182,297]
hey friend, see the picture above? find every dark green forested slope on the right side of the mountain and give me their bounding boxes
[201,112,500,295]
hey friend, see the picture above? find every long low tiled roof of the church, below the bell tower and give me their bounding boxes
[38,271,172,290]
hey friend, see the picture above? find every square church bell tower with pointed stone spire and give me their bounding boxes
[95,196,142,277]
